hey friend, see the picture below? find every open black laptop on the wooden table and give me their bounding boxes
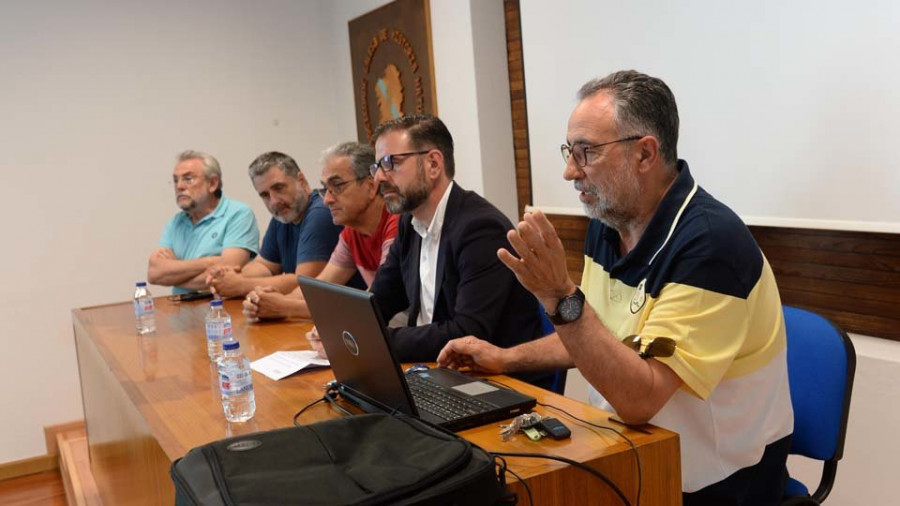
[297,276,537,431]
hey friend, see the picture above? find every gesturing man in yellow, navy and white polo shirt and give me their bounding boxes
[438,71,793,505]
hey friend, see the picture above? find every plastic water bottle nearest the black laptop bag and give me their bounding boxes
[219,341,256,422]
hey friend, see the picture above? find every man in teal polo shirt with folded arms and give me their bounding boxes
[147,151,259,293]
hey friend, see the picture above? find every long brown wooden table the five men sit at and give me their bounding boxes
[73,297,681,506]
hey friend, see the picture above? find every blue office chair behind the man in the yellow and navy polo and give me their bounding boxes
[782,306,856,506]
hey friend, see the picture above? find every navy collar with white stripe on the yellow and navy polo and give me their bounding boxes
[610,160,694,265]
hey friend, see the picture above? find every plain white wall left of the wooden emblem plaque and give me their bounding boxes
[0,0,355,463]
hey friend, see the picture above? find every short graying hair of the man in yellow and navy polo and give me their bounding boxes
[578,70,678,166]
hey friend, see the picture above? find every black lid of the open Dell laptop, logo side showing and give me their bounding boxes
[297,276,418,416]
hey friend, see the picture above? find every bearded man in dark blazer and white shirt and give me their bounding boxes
[371,116,548,388]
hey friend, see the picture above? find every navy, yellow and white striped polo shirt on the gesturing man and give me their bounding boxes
[582,160,794,492]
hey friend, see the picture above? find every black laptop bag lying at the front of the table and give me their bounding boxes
[172,414,515,506]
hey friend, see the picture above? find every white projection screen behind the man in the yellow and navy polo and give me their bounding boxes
[521,0,900,232]
